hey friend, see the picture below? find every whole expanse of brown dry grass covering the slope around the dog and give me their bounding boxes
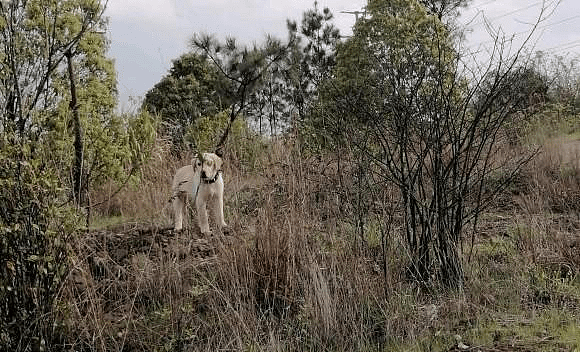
[53,133,580,351]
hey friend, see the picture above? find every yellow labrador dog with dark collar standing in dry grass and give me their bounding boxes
[172,153,228,234]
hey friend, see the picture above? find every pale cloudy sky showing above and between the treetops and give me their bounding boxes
[105,0,580,111]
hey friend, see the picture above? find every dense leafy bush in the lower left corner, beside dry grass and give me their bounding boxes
[0,135,80,351]
